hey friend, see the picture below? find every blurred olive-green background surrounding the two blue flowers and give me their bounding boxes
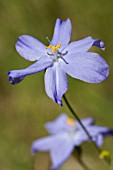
[0,0,113,170]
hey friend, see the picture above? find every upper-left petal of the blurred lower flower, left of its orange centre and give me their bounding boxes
[45,113,68,134]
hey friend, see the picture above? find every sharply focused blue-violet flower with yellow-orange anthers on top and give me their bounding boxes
[8,19,109,105]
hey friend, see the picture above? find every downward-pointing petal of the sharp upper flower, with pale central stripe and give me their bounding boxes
[45,62,68,106]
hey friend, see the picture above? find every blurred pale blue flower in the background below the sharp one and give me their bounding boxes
[32,114,113,170]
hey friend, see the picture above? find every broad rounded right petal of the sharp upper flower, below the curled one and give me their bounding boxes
[60,52,109,83]
